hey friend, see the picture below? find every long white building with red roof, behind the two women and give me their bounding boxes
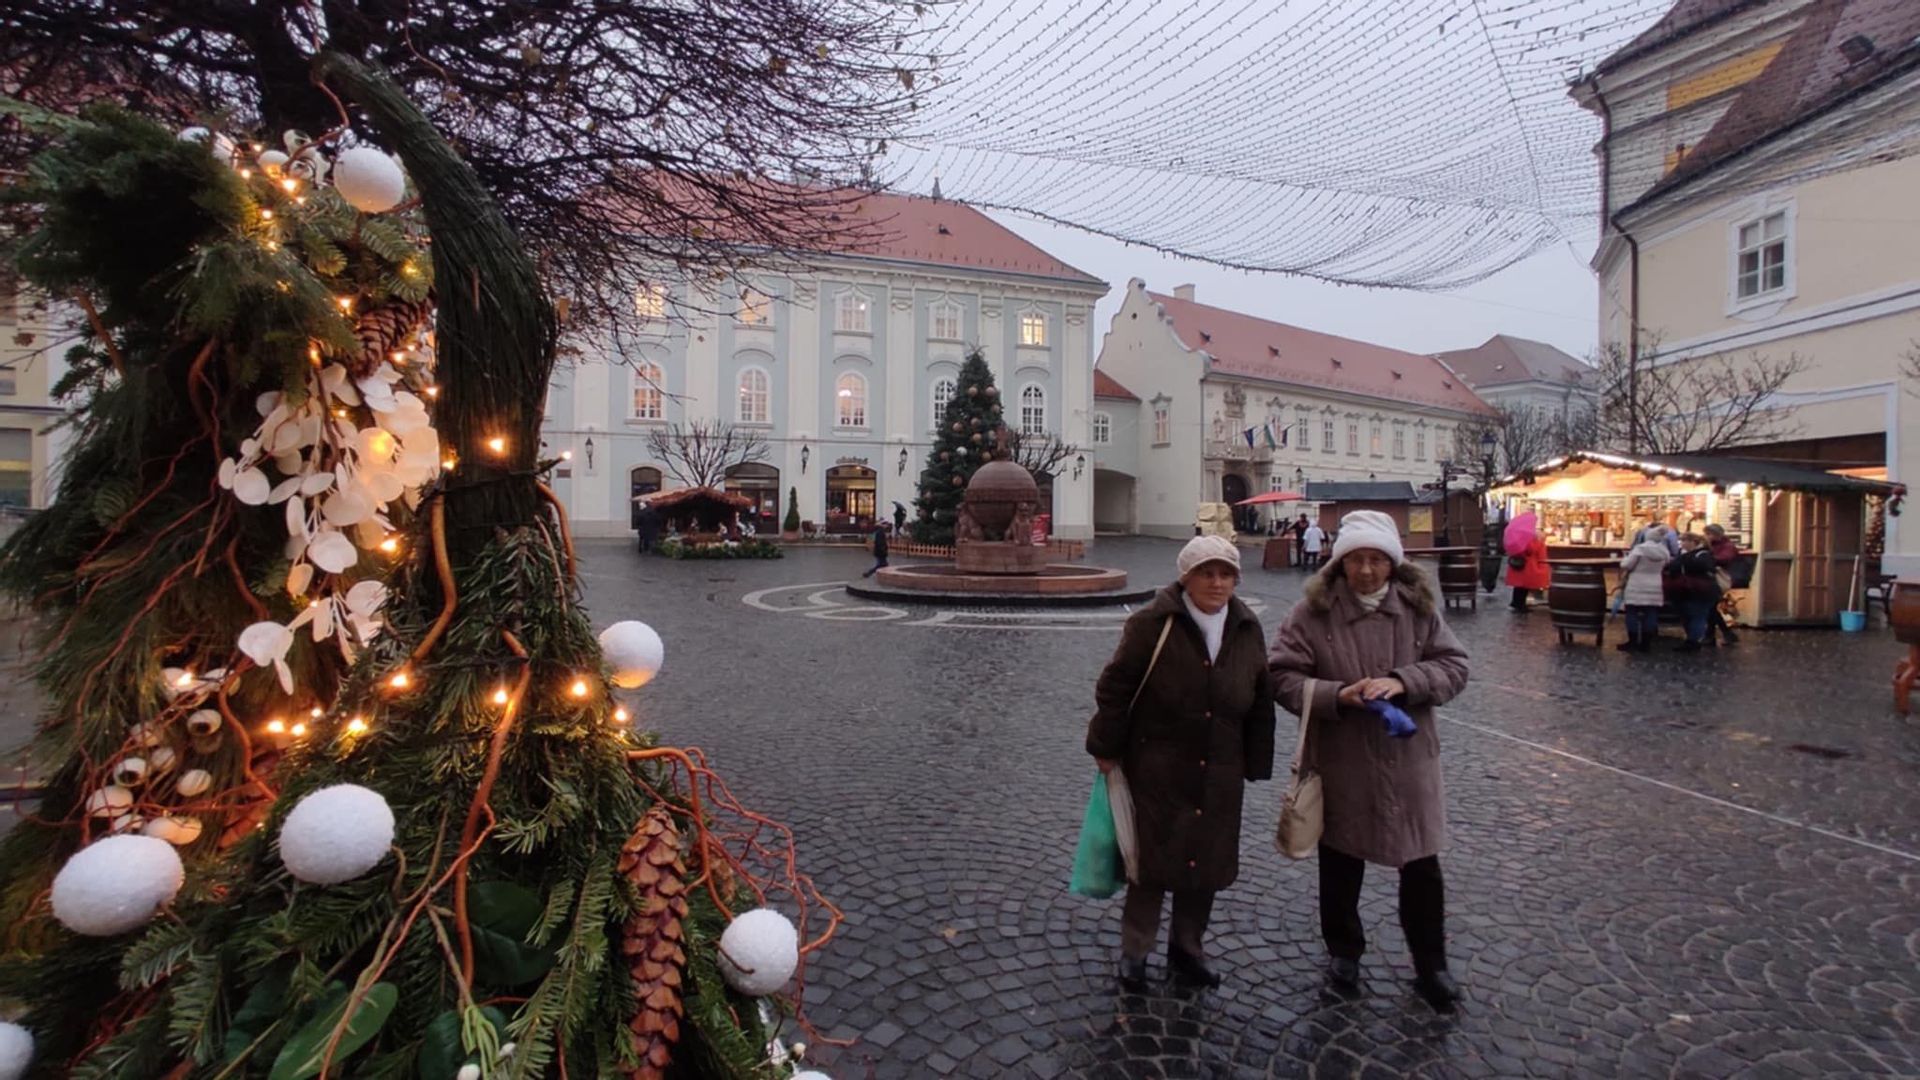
[1094,279,1494,536]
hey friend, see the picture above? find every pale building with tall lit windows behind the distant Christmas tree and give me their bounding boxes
[543,194,1108,538]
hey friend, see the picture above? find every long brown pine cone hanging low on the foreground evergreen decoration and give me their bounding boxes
[620,805,687,1080]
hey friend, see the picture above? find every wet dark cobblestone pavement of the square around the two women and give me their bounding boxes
[586,540,1920,1080]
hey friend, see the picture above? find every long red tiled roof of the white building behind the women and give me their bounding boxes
[1146,292,1492,413]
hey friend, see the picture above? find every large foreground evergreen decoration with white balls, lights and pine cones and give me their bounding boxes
[0,54,835,1080]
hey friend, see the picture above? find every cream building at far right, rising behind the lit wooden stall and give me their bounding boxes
[1572,0,1920,573]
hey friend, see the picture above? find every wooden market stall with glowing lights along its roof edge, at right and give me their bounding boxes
[1494,450,1905,626]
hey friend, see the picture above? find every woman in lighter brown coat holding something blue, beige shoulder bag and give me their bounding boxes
[1269,509,1467,1009]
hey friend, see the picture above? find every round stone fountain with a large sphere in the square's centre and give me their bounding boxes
[847,459,1154,605]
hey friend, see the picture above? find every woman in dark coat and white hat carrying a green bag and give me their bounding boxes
[1087,536,1273,990]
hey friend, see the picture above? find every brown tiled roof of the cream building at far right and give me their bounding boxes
[1649,0,1920,196]
